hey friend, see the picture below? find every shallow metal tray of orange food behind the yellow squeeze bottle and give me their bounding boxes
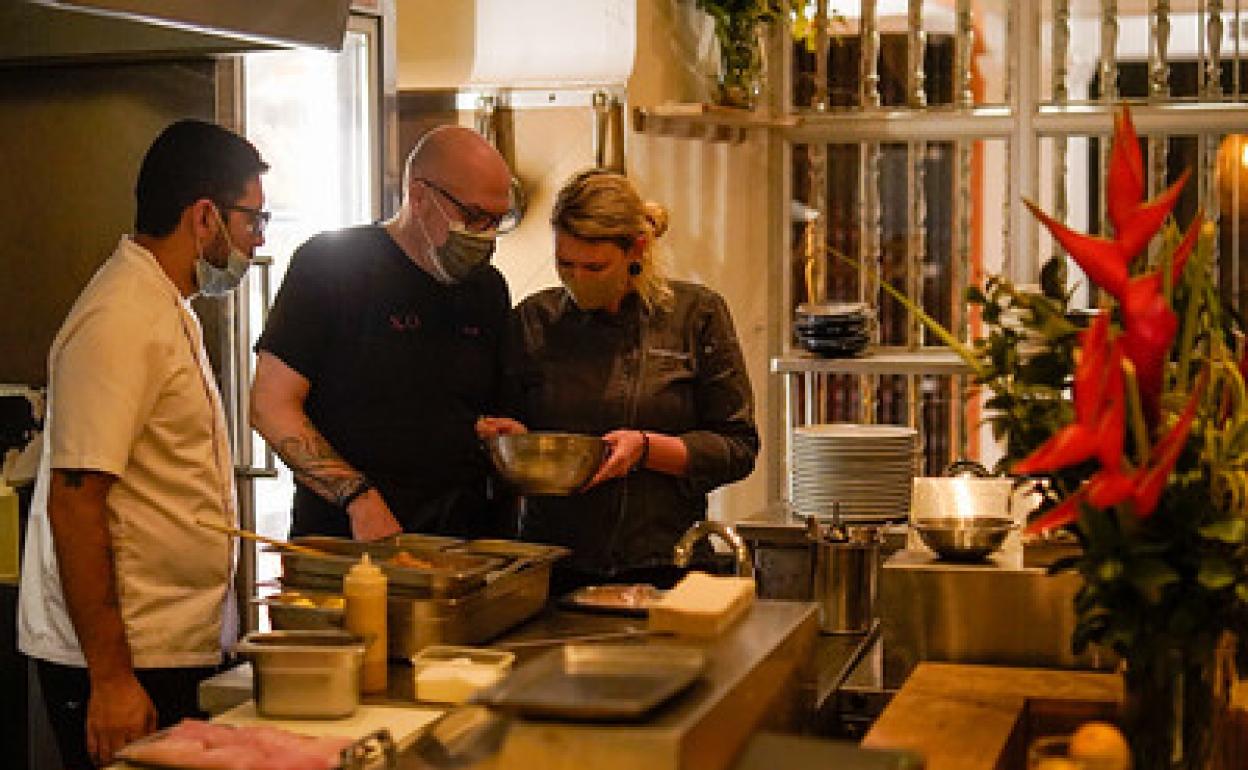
[282,535,505,597]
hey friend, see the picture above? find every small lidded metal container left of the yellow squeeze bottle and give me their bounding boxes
[237,631,364,719]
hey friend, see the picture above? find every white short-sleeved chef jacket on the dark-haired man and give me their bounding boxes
[17,237,237,668]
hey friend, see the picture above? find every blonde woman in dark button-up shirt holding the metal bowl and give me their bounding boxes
[478,170,759,590]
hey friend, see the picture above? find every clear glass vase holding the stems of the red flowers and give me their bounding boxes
[1122,641,1234,770]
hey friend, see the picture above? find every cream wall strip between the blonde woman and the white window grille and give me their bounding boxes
[626,0,782,520]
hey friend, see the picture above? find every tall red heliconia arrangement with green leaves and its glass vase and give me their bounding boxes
[838,103,1248,770]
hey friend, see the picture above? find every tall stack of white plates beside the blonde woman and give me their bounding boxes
[789,423,917,522]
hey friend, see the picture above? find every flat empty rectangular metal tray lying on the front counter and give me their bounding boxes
[477,644,706,721]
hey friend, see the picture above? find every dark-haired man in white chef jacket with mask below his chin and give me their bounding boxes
[17,120,268,769]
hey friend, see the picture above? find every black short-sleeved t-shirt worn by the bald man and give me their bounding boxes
[256,226,510,535]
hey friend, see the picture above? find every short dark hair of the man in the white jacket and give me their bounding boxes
[135,120,268,237]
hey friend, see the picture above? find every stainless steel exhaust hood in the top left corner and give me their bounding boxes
[0,0,351,64]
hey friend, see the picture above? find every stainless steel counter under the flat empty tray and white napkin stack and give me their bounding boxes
[201,600,828,770]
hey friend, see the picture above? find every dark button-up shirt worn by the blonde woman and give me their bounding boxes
[509,282,759,577]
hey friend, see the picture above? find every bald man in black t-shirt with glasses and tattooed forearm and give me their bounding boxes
[251,126,515,540]
